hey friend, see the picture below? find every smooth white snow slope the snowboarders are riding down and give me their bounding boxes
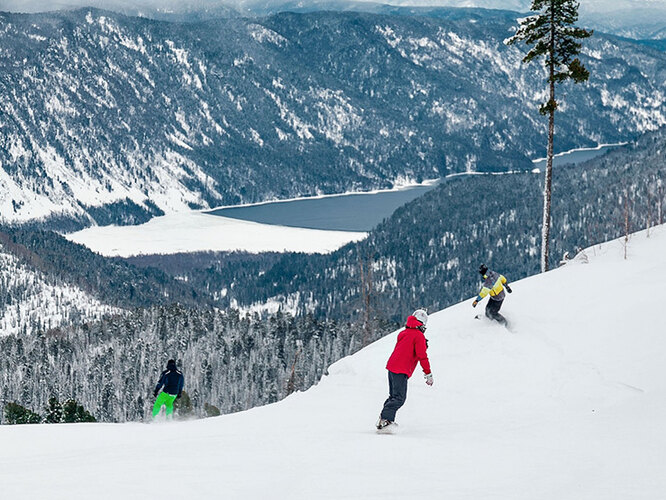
[0,227,666,500]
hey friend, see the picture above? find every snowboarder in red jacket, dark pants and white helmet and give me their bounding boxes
[377,309,433,430]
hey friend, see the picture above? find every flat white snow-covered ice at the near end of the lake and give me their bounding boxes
[65,211,367,257]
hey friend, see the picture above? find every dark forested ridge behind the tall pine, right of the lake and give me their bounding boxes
[161,129,666,321]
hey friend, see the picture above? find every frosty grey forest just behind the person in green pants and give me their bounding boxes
[0,305,363,422]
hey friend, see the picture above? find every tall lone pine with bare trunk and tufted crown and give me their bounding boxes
[507,0,592,272]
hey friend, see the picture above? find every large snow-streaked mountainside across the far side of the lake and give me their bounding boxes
[0,9,666,229]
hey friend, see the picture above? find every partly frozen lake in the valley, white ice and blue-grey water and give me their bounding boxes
[67,143,628,257]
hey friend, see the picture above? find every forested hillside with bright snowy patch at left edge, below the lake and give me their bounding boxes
[0,226,213,336]
